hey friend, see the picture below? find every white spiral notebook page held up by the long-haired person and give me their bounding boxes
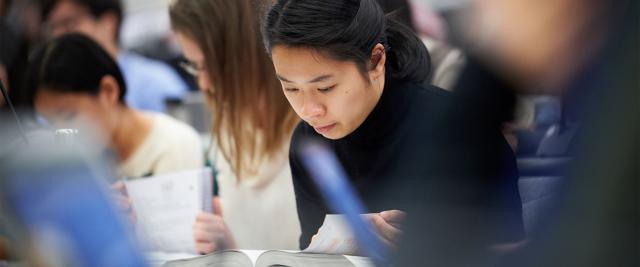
[125,169,211,253]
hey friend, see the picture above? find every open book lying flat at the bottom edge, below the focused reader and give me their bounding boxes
[162,250,373,267]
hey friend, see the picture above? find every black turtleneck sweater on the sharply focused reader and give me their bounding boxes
[289,79,523,249]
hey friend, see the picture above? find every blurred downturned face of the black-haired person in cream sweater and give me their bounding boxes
[34,76,120,148]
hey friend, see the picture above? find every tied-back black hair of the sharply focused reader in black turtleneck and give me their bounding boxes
[263,0,431,82]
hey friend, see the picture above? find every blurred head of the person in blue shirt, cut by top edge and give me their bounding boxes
[42,0,122,50]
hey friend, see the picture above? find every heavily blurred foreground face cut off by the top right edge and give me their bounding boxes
[420,0,609,93]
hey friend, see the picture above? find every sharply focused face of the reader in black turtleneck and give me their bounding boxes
[271,45,384,139]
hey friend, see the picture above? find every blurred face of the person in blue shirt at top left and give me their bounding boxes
[45,0,116,46]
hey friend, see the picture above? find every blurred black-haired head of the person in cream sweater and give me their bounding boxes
[30,34,126,147]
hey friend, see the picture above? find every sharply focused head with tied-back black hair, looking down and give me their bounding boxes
[263,0,429,139]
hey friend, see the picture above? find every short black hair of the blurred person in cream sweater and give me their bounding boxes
[29,33,127,105]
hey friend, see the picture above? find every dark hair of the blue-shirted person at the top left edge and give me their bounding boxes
[41,0,122,39]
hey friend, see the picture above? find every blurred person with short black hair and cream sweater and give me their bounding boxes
[29,34,204,179]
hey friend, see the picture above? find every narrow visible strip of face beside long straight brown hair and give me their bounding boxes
[176,32,213,92]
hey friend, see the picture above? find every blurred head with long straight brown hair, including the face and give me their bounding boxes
[169,0,297,180]
